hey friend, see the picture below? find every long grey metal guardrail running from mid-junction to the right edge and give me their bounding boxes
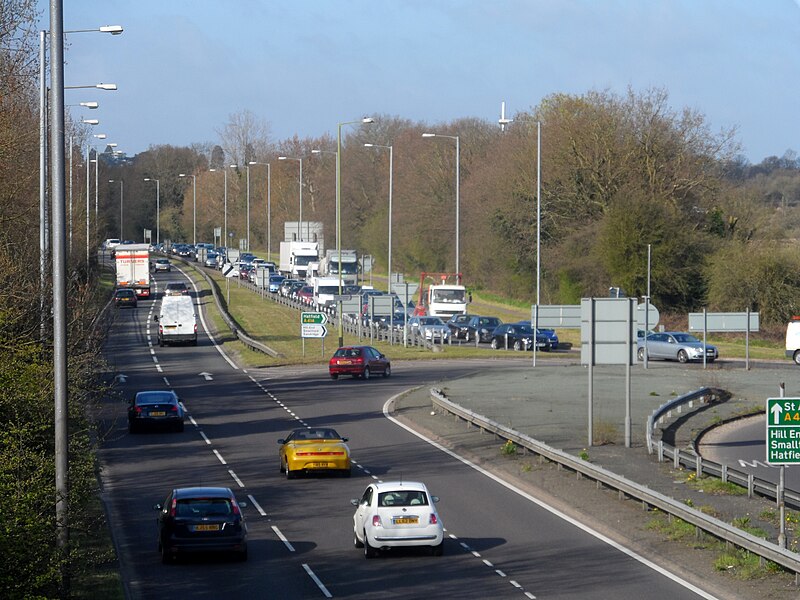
[431,389,800,578]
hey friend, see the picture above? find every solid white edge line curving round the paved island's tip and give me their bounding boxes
[383,392,719,600]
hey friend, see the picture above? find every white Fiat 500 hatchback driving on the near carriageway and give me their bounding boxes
[350,481,444,558]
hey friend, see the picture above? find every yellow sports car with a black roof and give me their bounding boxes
[278,427,350,479]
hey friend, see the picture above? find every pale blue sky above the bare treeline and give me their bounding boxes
[38,0,800,164]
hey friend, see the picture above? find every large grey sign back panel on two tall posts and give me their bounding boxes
[581,298,636,365]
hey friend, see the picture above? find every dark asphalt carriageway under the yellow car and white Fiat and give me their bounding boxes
[101,272,713,600]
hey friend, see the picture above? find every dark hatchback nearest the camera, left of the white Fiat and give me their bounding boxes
[153,487,247,563]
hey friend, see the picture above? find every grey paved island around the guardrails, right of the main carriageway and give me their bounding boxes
[394,354,800,600]
